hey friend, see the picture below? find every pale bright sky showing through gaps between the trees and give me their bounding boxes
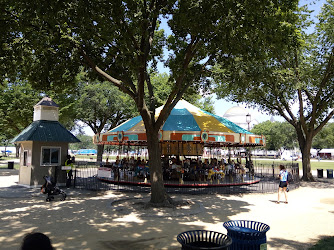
[85,0,326,135]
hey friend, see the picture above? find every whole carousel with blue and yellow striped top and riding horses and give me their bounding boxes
[94,100,265,188]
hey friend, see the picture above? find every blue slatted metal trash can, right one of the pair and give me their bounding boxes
[223,220,270,250]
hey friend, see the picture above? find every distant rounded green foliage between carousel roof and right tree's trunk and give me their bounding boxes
[251,121,298,151]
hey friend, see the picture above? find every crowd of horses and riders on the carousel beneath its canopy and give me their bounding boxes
[104,156,254,183]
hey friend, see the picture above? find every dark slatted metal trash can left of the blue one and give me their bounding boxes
[177,230,232,250]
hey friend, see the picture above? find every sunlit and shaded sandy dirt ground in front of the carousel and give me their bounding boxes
[0,169,334,250]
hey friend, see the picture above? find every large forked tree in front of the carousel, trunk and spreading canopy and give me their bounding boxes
[0,0,297,204]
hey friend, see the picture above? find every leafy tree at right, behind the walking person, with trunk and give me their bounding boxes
[216,0,334,180]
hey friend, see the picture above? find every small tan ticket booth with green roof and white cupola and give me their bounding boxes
[12,97,80,186]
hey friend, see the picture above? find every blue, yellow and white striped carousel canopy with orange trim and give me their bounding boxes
[94,100,264,149]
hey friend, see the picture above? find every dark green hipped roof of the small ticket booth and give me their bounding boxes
[11,120,80,143]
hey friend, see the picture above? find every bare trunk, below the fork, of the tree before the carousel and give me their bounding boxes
[146,129,170,204]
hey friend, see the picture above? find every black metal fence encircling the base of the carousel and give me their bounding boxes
[74,162,300,194]
